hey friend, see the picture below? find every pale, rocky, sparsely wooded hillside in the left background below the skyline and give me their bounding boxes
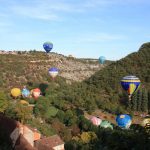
[0,51,104,88]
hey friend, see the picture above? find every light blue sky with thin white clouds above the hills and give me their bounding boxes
[0,0,150,60]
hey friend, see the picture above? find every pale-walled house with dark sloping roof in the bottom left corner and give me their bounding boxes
[0,114,41,150]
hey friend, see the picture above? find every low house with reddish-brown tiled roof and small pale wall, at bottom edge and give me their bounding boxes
[35,135,64,150]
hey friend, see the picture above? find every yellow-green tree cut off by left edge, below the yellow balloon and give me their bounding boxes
[0,91,8,113]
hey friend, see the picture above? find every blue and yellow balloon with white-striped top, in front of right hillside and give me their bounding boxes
[121,76,141,100]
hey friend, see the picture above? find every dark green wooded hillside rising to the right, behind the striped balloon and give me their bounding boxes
[59,43,150,113]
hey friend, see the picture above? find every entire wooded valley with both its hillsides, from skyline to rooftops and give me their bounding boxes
[0,43,150,150]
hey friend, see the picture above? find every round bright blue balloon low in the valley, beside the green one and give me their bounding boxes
[116,114,132,129]
